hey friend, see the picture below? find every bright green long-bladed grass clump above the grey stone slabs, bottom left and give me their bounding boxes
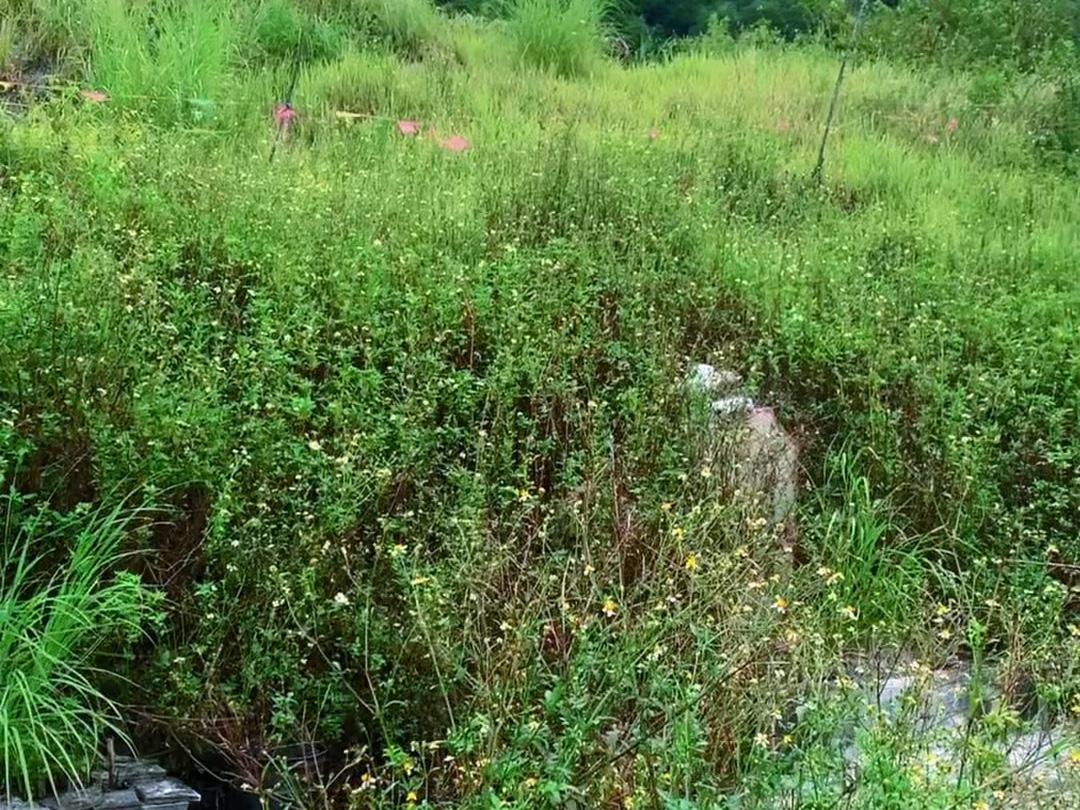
[0,492,159,799]
